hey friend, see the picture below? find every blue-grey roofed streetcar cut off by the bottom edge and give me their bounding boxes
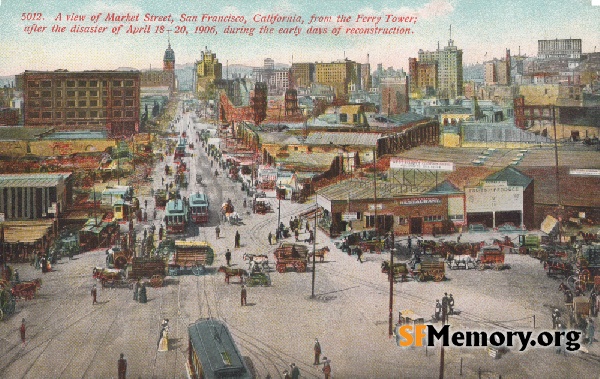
[186,318,254,379]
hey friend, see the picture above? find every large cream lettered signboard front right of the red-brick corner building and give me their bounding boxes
[465,182,523,213]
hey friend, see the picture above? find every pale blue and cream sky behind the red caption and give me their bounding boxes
[0,0,600,76]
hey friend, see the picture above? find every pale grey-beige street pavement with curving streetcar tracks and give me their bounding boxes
[0,105,600,378]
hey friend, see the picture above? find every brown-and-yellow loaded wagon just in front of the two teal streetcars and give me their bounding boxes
[168,240,215,276]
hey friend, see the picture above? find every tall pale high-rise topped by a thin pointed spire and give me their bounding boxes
[418,39,463,99]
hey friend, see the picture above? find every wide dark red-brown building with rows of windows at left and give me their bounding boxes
[20,70,140,138]
